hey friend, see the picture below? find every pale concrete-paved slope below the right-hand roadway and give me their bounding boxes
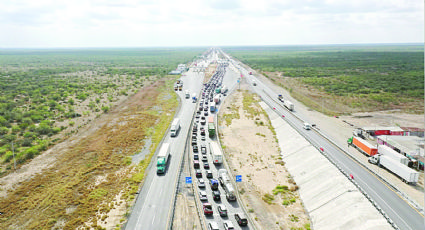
[260,102,393,230]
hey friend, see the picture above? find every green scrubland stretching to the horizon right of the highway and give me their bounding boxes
[224,45,424,115]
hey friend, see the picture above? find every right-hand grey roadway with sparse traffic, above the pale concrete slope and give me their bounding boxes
[225,50,424,230]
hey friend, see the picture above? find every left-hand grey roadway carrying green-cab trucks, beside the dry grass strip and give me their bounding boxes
[126,69,204,230]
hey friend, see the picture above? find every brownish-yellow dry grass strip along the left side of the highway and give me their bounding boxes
[0,80,177,229]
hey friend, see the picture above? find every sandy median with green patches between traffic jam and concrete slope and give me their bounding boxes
[219,84,310,229]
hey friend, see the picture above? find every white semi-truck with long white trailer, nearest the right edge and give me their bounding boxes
[368,154,419,184]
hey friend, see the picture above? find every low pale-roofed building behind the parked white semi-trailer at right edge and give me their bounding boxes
[377,135,425,170]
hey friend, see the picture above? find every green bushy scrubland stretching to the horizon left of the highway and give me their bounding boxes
[0,48,203,176]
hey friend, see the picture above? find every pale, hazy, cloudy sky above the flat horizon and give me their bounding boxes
[0,0,424,48]
